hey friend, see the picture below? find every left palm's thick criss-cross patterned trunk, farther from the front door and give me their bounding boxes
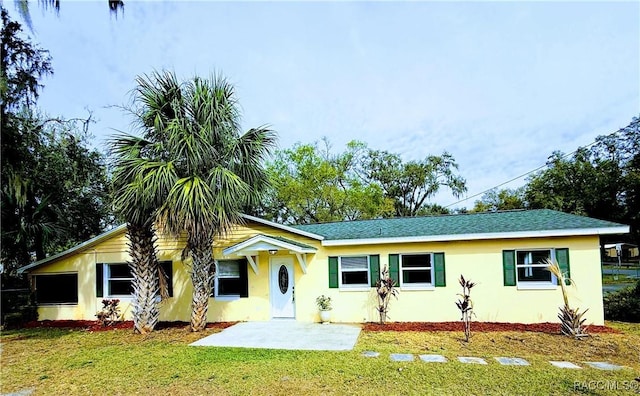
[127,221,160,334]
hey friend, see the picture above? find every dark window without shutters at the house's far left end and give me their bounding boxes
[35,273,78,305]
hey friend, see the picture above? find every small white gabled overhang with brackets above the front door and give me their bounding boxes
[222,234,318,275]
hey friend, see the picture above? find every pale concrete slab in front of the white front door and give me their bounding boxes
[191,320,360,351]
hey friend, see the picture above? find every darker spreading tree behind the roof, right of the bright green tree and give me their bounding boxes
[364,150,467,217]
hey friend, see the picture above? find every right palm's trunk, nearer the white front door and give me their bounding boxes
[190,240,214,331]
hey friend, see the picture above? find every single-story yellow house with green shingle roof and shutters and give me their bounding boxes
[21,210,629,325]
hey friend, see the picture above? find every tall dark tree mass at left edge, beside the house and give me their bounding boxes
[0,9,111,273]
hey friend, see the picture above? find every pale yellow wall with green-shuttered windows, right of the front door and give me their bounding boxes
[316,236,604,325]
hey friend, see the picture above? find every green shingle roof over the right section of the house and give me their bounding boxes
[294,209,625,240]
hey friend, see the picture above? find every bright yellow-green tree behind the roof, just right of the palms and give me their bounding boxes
[259,139,393,224]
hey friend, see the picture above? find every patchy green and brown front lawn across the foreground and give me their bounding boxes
[0,323,640,395]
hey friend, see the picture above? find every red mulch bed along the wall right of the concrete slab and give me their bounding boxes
[363,322,621,334]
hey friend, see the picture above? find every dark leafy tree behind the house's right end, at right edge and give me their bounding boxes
[525,117,640,244]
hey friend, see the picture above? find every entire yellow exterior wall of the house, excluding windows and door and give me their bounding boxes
[31,223,604,325]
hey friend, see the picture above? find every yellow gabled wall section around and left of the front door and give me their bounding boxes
[30,223,320,322]
